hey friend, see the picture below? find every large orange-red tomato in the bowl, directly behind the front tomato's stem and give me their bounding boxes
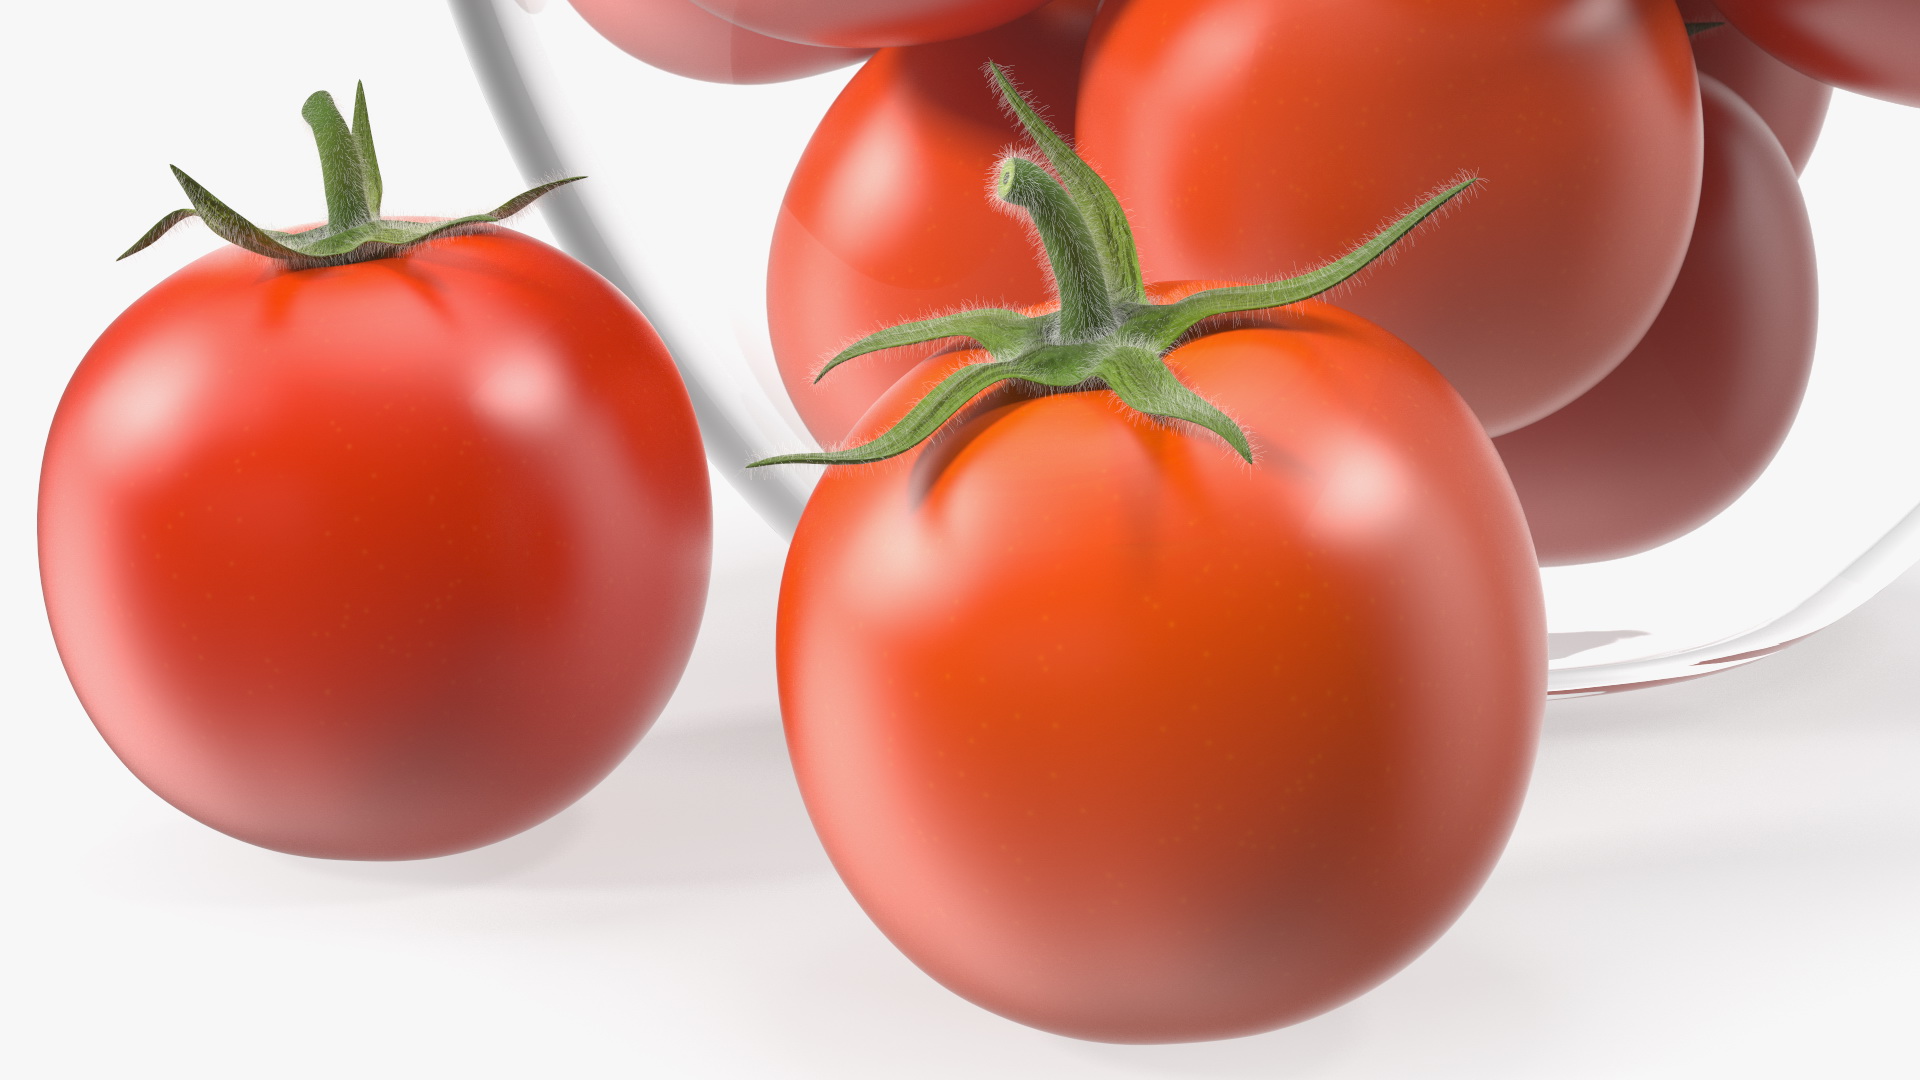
[1079,0,1701,434]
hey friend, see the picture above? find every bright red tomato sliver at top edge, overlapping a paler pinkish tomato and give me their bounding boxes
[695,0,1046,48]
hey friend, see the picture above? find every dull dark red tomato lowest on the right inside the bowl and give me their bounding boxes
[1494,77,1820,565]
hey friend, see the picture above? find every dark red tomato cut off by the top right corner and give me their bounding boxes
[1716,0,1920,106]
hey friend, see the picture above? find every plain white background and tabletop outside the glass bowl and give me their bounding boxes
[0,0,1920,1080]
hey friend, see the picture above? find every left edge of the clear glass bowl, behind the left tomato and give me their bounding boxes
[447,0,818,536]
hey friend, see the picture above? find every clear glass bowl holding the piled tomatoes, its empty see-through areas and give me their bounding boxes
[451,0,1920,694]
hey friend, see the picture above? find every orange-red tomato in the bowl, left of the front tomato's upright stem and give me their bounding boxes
[766,0,1096,446]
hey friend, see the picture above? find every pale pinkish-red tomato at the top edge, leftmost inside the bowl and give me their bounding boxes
[570,0,868,83]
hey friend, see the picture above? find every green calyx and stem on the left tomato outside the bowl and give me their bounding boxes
[119,85,582,269]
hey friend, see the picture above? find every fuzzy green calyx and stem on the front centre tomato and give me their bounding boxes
[747,63,1480,469]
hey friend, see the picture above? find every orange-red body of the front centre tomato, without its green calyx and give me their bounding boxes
[778,304,1546,1042]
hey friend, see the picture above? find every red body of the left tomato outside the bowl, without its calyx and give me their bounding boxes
[38,229,710,859]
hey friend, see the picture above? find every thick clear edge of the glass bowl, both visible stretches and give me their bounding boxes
[449,0,1920,698]
